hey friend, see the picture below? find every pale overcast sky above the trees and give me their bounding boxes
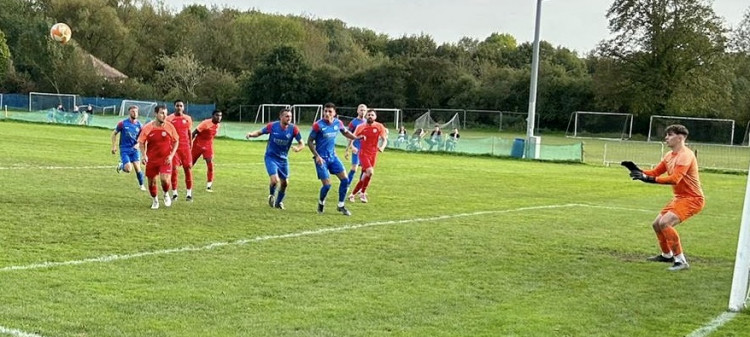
[164,0,750,55]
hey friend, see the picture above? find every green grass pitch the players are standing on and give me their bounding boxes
[0,122,750,337]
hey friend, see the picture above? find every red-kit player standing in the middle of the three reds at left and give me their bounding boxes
[167,99,193,201]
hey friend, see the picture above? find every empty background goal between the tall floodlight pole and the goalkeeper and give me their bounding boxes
[565,111,633,139]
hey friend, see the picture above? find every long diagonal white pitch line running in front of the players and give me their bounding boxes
[0,204,587,272]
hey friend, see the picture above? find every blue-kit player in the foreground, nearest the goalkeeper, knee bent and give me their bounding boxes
[307,103,361,215]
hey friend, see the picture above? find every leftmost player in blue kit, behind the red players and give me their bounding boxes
[112,105,146,191]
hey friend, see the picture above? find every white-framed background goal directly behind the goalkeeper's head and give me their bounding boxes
[647,115,734,145]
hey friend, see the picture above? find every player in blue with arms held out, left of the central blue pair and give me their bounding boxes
[246,108,305,209]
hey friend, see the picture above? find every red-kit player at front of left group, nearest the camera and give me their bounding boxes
[138,105,180,209]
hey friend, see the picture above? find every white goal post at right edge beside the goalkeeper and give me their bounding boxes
[729,165,750,311]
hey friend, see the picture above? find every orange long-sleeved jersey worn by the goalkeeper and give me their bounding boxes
[643,146,703,198]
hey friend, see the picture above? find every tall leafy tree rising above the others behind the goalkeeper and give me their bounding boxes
[597,0,726,114]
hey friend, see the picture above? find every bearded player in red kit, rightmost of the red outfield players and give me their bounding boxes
[349,109,388,202]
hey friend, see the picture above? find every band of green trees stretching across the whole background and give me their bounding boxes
[0,0,750,135]
